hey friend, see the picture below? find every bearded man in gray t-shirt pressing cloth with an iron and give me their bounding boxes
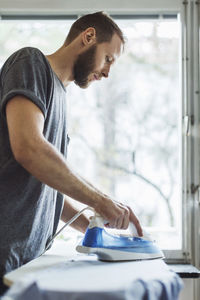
[0,12,142,296]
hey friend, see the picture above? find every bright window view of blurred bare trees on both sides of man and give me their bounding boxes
[0,19,181,249]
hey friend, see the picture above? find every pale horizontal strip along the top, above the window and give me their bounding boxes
[0,0,181,15]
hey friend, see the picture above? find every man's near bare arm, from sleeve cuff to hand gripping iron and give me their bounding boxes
[6,96,142,235]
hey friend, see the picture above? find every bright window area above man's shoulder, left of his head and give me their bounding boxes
[0,20,73,66]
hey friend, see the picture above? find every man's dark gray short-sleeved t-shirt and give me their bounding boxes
[0,47,68,277]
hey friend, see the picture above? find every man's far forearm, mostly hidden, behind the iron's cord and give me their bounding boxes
[61,197,89,233]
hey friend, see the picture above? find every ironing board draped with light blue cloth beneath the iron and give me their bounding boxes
[3,241,182,300]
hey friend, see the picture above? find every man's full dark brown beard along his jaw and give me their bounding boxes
[73,45,96,89]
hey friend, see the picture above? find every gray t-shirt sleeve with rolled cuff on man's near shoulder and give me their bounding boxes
[0,56,49,117]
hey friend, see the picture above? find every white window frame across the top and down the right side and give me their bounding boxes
[0,0,200,267]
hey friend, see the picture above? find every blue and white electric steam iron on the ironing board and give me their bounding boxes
[76,214,164,261]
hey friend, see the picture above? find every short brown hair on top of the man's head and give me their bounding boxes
[64,11,125,45]
